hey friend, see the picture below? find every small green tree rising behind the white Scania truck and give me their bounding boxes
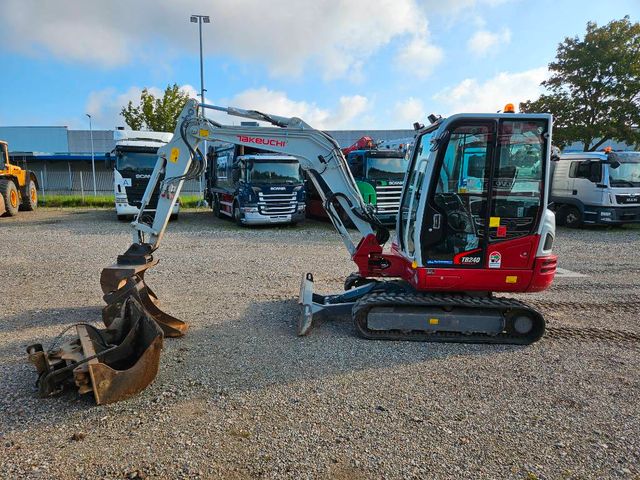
[120,83,189,132]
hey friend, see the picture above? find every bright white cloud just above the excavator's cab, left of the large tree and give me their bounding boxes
[433,67,549,115]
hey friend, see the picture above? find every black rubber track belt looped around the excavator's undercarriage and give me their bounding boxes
[352,292,545,345]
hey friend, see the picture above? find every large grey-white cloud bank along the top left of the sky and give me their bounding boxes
[0,0,444,79]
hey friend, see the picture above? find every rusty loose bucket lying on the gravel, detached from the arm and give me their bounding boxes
[27,297,163,405]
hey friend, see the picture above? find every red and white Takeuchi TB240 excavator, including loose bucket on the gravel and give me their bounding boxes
[29,100,557,403]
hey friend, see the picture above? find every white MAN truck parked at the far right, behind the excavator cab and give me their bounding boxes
[550,151,640,228]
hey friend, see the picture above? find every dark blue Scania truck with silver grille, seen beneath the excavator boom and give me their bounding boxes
[205,143,305,225]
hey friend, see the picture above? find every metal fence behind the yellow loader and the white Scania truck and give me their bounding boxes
[29,163,201,195]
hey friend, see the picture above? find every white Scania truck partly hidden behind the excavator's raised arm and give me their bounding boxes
[106,130,180,220]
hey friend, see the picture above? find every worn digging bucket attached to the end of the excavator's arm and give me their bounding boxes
[100,260,189,337]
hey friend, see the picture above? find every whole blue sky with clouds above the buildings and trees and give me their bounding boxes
[0,0,640,129]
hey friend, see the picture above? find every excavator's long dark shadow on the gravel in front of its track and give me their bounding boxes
[179,300,516,391]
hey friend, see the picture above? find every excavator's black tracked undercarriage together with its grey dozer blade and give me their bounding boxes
[298,274,545,345]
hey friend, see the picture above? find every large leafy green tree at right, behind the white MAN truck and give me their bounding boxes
[520,16,640,151]
